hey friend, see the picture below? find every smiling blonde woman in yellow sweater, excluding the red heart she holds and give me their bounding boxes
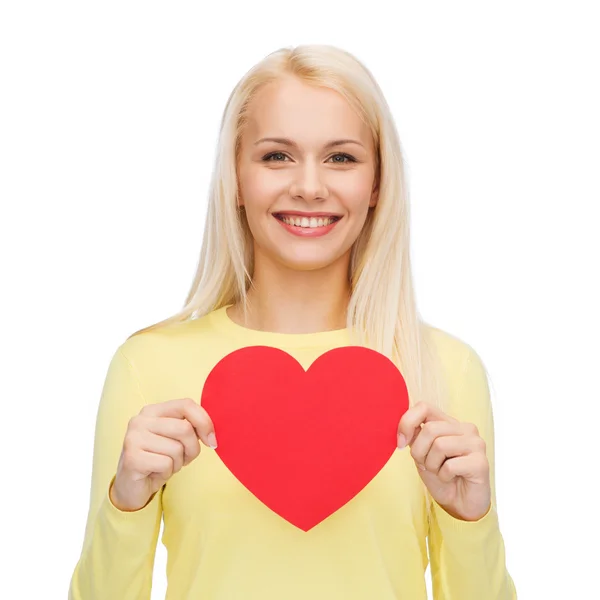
[70,46,516,600]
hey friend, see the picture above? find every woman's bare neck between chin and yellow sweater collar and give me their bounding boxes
[228,251,351,333]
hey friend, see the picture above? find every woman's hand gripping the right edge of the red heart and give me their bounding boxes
[398,402,492,521]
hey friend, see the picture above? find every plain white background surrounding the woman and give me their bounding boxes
[0,0,600,600]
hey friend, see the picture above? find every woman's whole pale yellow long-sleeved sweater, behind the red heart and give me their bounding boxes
[69,308,516,600]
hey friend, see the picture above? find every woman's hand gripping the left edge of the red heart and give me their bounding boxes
[109,398,216,511]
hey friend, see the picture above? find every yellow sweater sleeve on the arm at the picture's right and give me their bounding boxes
[428,347,517,600]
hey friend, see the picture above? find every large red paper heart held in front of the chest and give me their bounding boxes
[201,346,408,531]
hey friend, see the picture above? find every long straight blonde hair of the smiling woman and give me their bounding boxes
[130,45,447,409]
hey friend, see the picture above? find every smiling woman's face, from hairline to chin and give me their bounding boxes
[238,78,377,270]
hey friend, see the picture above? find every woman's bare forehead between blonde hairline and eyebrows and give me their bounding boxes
[247,77,370,145]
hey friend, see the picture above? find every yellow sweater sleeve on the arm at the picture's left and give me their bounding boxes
[69,347,162,600]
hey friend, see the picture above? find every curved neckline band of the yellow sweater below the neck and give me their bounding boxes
[210,304,350,348]
